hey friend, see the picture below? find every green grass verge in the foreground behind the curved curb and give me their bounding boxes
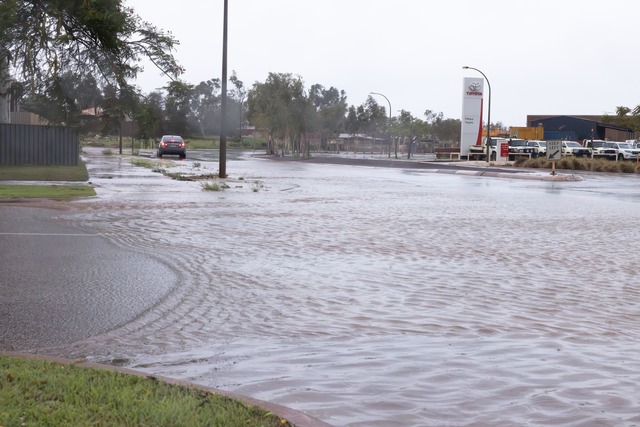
[0,356,292,427]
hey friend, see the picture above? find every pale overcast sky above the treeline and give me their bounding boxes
[125,0,640,126]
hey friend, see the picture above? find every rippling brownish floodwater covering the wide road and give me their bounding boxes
[37,149,640,427]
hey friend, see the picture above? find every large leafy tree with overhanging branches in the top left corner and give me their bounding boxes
[0,0,183,123]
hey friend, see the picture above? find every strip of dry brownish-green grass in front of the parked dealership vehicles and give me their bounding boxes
[514,156,640,174]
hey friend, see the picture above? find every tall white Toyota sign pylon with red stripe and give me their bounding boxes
[460,77,484,156]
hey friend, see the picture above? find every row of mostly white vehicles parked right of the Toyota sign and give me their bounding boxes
[469,137,640,160]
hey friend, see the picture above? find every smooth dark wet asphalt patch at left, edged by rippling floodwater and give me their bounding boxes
[0,203,176,352]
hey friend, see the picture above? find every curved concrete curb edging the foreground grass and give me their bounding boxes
[0,351,333,427]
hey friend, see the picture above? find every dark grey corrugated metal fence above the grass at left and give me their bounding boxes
[0,124,80,166]
